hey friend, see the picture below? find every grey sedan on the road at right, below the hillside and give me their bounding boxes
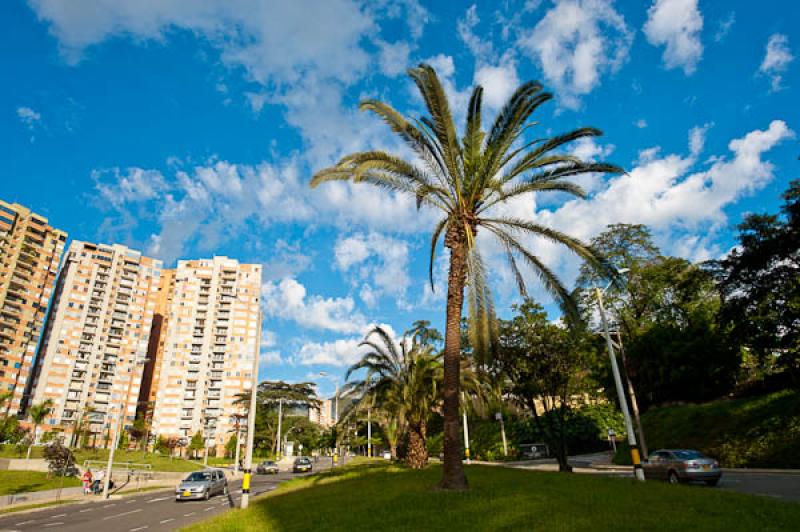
[642,449,722,486]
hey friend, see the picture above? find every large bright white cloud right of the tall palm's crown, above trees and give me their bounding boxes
[537,120,794,262]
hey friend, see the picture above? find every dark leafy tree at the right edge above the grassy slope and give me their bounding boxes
[717,180,800,386]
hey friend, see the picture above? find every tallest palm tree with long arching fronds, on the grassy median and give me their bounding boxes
[311,64,622,489]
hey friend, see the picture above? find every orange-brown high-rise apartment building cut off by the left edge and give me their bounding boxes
[0,201,67,415]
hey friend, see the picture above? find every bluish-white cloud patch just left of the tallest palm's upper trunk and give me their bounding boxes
[334,232,411,307]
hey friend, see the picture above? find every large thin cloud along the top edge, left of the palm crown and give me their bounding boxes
[29,0,429,168]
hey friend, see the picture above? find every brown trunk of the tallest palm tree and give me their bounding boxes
[440,241,467,490]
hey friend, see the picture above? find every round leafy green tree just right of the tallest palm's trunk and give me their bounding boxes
[497,300,593,471]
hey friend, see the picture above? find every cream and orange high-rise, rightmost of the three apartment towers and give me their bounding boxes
[152,257,261,453]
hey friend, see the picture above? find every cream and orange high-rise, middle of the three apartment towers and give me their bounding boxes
[33,240,161,445]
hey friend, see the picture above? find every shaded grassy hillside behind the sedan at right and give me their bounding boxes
[615,390,800,468]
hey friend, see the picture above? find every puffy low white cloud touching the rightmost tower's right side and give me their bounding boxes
[261,278,366,333]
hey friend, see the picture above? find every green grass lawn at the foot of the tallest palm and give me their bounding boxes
[186,463,800,532]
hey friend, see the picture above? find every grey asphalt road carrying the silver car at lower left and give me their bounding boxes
[0,461,330,532]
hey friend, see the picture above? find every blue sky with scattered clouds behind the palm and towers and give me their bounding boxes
[0,0,800,393]
